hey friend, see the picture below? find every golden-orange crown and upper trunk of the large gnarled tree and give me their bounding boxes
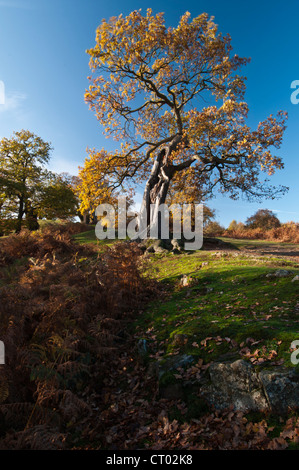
[85,9,287,239]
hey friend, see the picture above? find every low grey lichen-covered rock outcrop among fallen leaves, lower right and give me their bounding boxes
[154,354,299,415]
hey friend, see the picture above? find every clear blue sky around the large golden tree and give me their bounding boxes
[0,0,299,226]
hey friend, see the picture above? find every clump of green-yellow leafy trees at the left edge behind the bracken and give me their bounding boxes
[0,130,78,232]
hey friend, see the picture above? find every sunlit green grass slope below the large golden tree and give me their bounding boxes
[135,251,299,367]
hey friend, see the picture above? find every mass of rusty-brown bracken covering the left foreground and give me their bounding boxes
[0,228,152,449]
